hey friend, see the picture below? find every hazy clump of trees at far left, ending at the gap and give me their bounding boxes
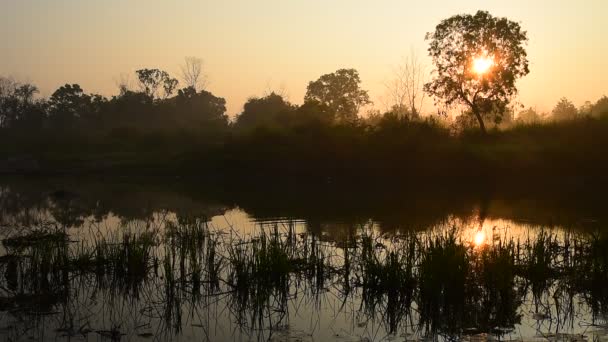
[0,69,228,136]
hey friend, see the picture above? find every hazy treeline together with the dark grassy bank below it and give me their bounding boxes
[0,69,608,185]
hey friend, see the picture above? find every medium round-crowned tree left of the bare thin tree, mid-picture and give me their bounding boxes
[304,69,371,122]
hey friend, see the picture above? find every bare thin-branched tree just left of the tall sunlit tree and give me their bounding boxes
[385,52,426,118]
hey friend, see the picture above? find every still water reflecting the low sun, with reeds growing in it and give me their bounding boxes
[0,179,608,341]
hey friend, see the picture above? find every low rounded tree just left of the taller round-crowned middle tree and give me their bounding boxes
[235,92,295,129]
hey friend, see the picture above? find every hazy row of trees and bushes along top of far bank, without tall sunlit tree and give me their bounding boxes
[0,69,608,138]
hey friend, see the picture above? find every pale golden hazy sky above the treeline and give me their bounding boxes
[0,0,608,114]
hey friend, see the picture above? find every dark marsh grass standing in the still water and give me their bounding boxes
[0,218,608,338]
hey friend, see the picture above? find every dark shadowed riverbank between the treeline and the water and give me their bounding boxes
[0,118,608,190]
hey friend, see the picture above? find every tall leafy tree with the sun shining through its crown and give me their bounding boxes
[425,11,529,133]
